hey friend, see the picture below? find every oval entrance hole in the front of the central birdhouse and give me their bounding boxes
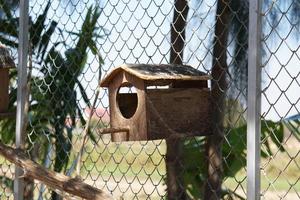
[116,83,138,119]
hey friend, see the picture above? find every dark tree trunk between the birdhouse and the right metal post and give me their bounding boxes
[204,0,230,200]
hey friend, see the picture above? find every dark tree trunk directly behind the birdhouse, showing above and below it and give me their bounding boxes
[166,0,189,200]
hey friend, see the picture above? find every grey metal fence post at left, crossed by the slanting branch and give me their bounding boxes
[14,0,29,200]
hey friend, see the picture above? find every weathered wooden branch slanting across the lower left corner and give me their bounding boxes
[0,142,113,200]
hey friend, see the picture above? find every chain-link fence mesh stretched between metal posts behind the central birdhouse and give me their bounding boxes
[0,0,300,200]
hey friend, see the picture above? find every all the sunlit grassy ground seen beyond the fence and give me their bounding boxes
[0,134,300,200]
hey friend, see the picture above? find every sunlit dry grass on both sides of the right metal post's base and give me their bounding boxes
[223,139,300,200]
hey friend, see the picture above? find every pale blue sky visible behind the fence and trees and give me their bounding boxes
[30,0,300,120]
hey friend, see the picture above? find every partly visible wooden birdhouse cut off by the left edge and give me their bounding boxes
[0,44,15,114]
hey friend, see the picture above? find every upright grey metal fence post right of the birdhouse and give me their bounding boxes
[247,0,261,200]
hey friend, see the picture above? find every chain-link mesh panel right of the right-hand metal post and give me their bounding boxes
[261,1,300,199]
